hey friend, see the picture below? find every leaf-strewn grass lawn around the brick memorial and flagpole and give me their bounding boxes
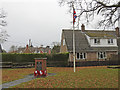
[6,66,120,88]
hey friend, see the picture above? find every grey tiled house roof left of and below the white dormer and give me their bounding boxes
[62,29,118,52]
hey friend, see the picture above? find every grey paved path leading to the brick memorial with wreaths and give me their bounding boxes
[0,73,56,88]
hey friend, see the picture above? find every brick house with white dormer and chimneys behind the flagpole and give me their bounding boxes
[60,25,119,62]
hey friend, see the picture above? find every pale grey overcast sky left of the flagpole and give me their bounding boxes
[0,0,117,51]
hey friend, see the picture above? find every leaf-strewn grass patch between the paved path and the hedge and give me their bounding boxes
[2,68,34,83]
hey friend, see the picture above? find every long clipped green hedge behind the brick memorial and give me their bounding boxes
[2,53,69,66]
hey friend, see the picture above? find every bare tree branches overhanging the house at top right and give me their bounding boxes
[59,0,120,27]
